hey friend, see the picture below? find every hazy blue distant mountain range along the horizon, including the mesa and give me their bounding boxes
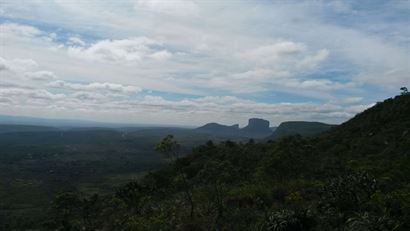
[0,115,335,140]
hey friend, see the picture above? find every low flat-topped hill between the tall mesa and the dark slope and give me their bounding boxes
[267,121,336,140]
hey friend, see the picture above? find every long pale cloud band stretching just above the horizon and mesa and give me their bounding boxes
[0,83,369,125]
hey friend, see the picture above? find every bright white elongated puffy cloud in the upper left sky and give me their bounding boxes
[68,37,172,62]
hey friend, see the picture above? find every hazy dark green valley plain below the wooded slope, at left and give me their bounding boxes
[0,128,248,230]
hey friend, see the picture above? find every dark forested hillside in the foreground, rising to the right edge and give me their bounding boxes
[0,94,410,231]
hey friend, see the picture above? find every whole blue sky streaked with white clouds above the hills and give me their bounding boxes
[0,0,410,126]
